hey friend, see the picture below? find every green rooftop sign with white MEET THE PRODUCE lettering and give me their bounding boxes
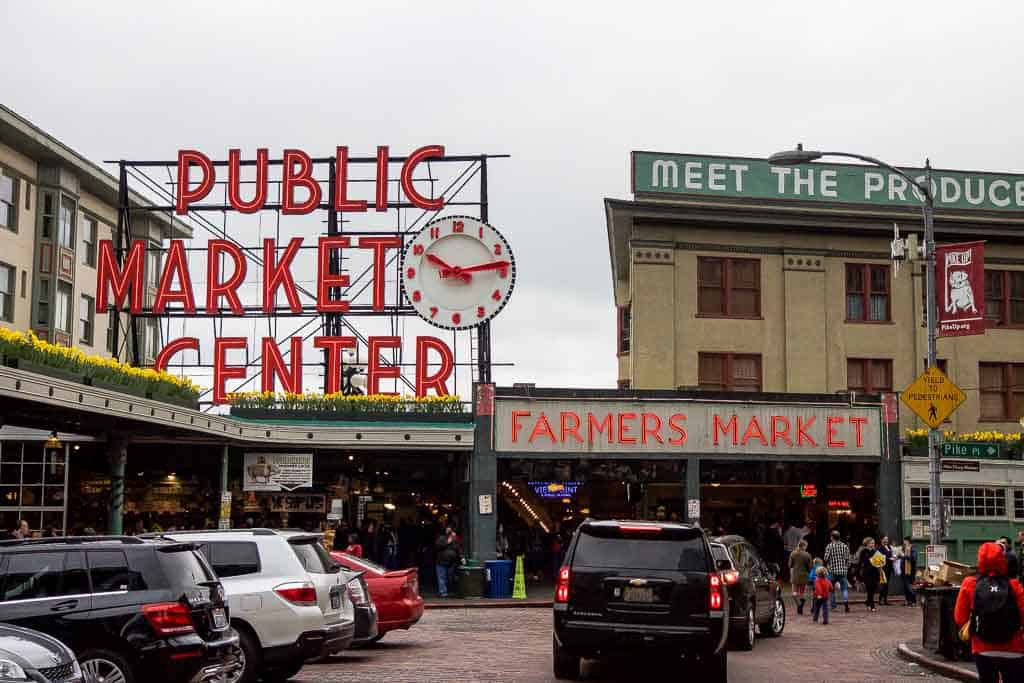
[632,152,1024,212]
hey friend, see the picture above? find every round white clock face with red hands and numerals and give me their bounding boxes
[401,216,515,330]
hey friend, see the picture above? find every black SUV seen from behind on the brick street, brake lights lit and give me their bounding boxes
[553,519,729,681]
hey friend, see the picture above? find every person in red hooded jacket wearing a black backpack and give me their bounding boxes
[953,543,1024,683]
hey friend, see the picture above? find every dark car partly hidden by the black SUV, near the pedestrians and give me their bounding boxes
[711,536,785,650]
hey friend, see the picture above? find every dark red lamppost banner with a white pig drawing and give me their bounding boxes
[935,242,985,337]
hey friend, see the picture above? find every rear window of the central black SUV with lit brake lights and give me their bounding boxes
[572,532,708,571]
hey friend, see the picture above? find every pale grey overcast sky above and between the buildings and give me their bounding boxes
[6,0,1024,393]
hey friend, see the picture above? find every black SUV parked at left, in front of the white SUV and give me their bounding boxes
[0,537,239,683]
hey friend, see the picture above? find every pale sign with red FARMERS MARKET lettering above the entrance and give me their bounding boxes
[494,398,882,457]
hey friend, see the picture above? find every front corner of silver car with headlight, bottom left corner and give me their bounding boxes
[0,624,93,683]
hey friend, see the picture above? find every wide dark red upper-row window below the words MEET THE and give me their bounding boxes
[697,257,761,317]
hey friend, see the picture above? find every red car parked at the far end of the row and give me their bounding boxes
[331,551,423,641]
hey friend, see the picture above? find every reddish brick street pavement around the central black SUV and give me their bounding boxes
[296,605,950,683]
